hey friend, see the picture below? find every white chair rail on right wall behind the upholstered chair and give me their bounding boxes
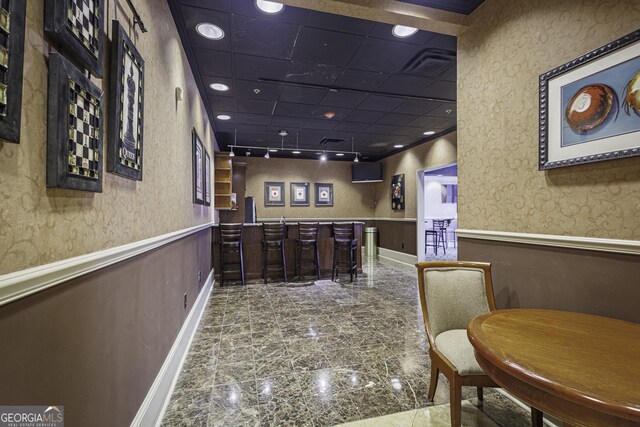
[456,229,640,255]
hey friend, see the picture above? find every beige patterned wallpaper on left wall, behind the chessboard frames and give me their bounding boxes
[0,0,214,274]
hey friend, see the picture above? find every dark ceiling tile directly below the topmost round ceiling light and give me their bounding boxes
[232,15,300,59]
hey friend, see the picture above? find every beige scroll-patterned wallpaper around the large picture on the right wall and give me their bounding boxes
[458,0,640,240]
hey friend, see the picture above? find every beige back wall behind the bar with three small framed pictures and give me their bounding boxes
[243,157,376,221]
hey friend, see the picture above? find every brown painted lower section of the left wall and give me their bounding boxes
[0,229,211,427]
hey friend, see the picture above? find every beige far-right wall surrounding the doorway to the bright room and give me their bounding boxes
[375,132,457,219]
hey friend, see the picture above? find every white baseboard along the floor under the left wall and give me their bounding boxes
[131,270,214,427]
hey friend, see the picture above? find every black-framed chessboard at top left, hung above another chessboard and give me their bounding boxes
[44,0,106,78]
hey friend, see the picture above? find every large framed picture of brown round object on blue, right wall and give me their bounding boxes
[538,30,640,170]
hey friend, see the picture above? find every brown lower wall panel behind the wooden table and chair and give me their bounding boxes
[458,238,640,323]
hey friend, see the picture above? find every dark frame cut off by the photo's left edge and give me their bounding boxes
[0,0,27,143]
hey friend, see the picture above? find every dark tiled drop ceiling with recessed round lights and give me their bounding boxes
[169,0,480,161]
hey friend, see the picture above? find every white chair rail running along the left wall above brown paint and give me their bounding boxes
[0,222,215,306]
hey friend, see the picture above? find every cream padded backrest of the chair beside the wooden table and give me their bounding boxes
[416,261,496,345]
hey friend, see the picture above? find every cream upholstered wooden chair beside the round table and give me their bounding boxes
[416,261,498,427]
